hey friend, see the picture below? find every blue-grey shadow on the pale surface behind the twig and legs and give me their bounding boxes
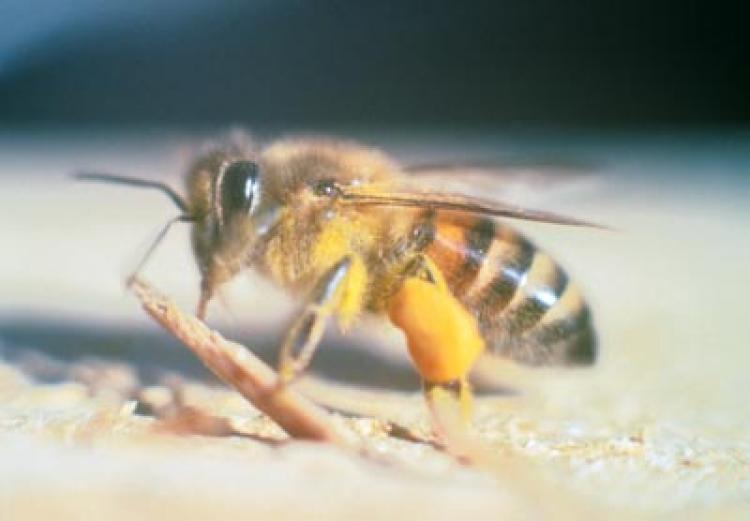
[0,319,419,391]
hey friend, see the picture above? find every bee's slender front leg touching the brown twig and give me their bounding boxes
[279,257,352,386]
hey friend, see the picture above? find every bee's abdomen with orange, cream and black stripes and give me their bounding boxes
[420,212,596,365]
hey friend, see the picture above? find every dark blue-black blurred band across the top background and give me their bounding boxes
[0,0,750,128]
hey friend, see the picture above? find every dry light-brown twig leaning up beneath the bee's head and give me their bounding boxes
[131,279,346,445]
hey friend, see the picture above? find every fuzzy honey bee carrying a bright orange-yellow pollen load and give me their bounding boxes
[78,135,597,418]
